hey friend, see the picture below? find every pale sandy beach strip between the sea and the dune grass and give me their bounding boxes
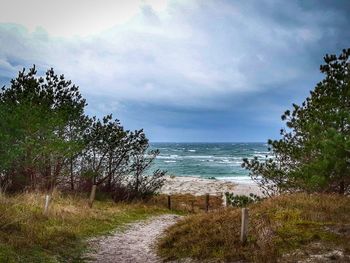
[160,176,261,195]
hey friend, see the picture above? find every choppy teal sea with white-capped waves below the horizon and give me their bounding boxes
[151,143,268,182]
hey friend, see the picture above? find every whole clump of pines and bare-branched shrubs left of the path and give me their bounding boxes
[0,67,165,200]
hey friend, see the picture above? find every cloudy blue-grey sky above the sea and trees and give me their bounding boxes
[0,0,350,142]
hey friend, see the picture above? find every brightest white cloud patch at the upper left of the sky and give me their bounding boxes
[0,0,166,37]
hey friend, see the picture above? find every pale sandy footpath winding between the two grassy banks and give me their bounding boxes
[86,215,181,263]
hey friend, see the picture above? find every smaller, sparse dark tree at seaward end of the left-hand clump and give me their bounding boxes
[83,115,163,205]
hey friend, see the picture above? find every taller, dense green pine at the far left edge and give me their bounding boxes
[0,67,86,190]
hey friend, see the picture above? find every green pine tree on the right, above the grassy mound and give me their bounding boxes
[242,49,350,195]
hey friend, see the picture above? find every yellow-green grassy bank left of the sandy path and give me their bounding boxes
[0,193,168,263]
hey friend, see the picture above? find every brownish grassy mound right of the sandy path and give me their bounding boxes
[158,194,350,262]
